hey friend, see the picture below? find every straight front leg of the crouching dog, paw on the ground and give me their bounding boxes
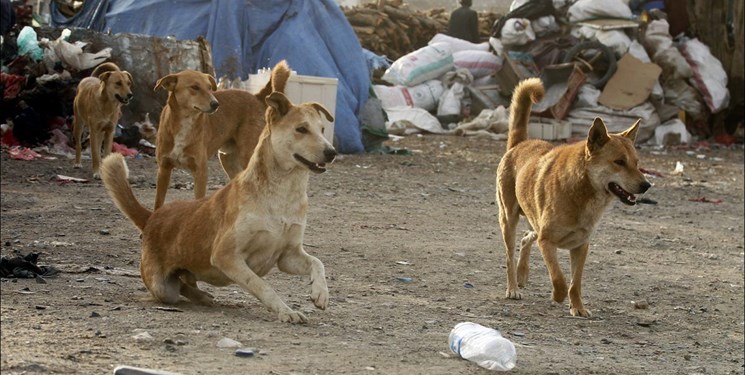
[210,245,308,323]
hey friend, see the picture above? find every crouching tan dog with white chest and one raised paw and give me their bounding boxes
[102,92,336,323]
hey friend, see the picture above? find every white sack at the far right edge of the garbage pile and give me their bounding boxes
[681,38,730,113]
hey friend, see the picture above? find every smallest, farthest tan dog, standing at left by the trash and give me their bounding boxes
[73,62,133,179]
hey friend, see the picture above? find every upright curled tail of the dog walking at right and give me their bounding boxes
[507,78,544,150]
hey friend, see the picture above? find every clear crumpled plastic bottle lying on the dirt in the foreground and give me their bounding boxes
[448,322,517,371]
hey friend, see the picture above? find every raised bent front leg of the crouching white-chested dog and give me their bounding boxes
[277,246,329,310]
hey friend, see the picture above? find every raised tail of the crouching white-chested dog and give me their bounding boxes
[101,153,152,231]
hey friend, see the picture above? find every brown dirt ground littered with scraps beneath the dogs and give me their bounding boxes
[0,136,745,375]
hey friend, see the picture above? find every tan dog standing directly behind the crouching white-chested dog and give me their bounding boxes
[155,60,290,210]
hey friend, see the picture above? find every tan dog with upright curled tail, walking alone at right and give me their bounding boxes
[496,78,651,317]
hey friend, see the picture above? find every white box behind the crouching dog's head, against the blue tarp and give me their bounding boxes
[246,72,339,143]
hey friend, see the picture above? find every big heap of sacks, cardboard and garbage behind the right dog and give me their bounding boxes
[355,0,740,145]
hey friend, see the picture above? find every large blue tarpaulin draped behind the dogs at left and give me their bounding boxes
[51,0,370,153]
